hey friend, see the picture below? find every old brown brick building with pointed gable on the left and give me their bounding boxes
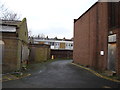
[0,18,29,73]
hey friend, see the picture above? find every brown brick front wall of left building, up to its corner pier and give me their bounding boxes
[2,39,18,73]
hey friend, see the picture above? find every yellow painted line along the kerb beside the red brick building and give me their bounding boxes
[71,63,120,82]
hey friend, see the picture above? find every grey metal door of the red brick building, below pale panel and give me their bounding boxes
[108,43,116,71]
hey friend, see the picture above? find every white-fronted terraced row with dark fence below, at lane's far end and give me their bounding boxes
[32,37,73,59]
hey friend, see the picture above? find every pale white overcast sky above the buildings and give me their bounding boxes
[0,0,97,38]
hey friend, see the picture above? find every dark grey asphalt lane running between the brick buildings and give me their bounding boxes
[2,60,120,88]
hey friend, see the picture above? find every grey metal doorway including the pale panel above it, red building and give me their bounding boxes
[108,35,116,71]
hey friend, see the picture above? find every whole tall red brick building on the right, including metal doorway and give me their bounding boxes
[73,2,120,75]
